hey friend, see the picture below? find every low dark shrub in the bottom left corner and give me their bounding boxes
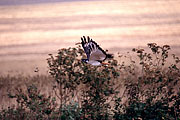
[1,85,56,119]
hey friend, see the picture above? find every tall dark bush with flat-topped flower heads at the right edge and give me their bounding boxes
[113,43,180,120]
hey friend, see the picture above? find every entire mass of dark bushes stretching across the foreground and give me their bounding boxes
[0,43,180,120]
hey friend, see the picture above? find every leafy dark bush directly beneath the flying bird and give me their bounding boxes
[48,48,119,119]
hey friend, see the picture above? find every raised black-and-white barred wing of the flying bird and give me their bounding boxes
[81,36,107,61]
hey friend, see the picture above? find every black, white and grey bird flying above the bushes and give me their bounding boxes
[76,36,113,66]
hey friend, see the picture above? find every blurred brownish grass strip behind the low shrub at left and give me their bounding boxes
[0,75,53,108]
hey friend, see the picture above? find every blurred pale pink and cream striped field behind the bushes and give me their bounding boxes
[0,0,180,75]
